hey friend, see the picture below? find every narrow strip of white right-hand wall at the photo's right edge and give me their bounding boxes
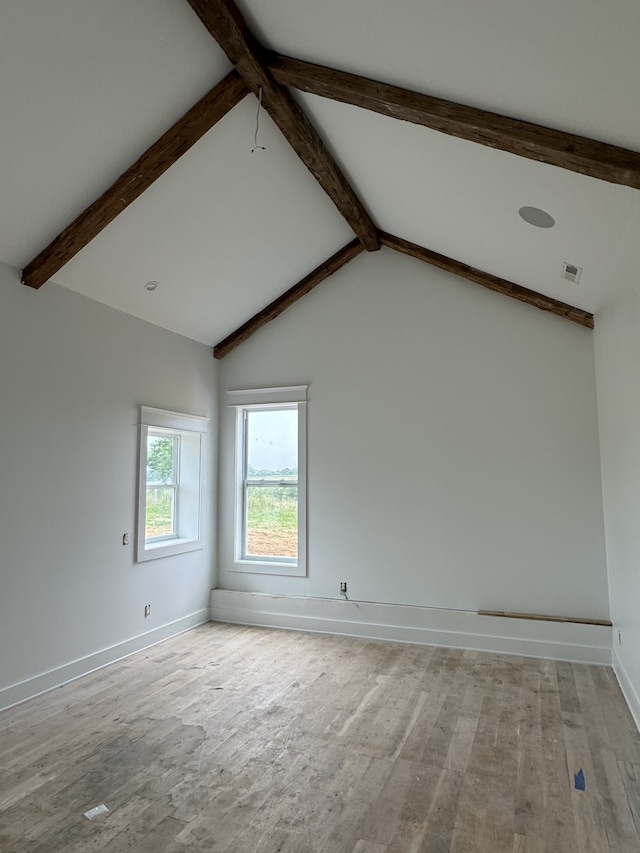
[595,200,640,726]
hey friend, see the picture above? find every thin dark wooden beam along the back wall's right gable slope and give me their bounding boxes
[380,231,594,329]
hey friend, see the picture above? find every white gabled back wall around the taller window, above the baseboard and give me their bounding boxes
[218,245,609,618]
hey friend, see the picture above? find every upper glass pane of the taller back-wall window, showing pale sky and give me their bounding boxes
[246,409,298,481]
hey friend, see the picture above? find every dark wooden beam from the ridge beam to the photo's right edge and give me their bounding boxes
[268,54,640,189]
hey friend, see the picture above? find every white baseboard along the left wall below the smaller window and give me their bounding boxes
[0,609,209,711]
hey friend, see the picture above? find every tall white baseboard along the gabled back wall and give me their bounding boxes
[210,589,612,666]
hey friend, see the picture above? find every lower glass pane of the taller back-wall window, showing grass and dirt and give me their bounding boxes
[246,486,298,558]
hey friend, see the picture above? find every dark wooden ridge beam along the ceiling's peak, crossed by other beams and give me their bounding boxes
[182,0,380,252]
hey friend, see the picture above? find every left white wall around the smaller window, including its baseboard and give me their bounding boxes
[0,265,217,707]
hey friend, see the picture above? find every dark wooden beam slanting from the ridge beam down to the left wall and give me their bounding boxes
[22,71,249,288]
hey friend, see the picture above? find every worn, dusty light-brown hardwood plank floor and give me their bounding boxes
[0,623,640,853]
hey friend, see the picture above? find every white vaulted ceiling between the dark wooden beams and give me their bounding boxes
[0,0,640,344]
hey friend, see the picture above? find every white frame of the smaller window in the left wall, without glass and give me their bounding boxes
[136,406,209,563]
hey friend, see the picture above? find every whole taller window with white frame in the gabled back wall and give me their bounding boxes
[229,386,306,575]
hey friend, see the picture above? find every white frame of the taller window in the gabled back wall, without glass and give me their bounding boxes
[227,385,307,577]
